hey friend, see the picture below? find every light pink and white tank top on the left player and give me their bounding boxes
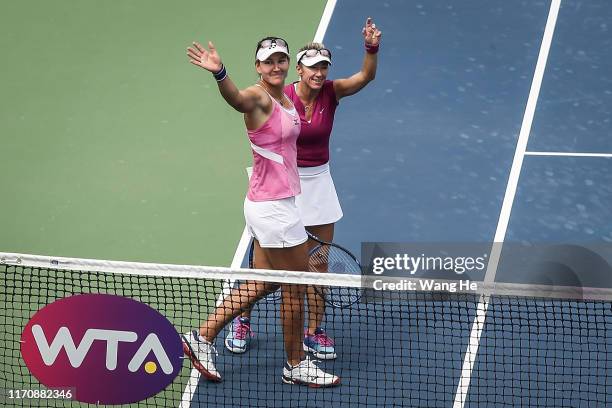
[247,88,300,201]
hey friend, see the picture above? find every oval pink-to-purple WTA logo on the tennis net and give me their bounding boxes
[21,295,183,404]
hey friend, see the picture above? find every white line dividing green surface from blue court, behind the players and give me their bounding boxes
[179,0,336,408]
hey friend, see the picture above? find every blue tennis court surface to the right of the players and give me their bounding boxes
[186,0,612,407]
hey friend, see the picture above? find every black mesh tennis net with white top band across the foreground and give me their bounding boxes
[0,253,612,407]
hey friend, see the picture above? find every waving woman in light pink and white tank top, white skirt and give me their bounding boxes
[182,37,340,387]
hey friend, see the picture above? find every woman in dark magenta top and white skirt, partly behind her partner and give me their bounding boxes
[230,18,382,360]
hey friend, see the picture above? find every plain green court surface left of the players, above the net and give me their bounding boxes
[0,0,325,265]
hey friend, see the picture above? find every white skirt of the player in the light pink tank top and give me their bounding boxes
[244,197,308,248]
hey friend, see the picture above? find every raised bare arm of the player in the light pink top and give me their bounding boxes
[187,41,263,114]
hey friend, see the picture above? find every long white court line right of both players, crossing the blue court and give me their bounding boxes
[453,0,561,408]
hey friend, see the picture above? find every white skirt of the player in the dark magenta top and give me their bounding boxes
[295,163,342,227]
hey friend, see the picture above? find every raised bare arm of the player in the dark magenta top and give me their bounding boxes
[334,17,382,100]
